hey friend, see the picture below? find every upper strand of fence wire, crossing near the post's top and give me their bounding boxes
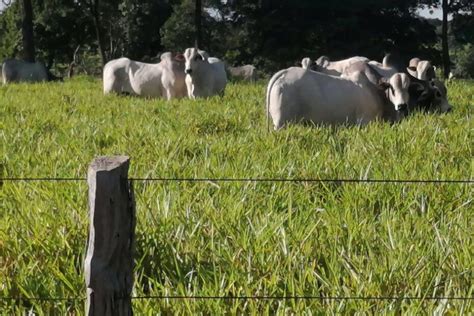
[0,177,474,184]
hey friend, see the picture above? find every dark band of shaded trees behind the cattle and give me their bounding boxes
[0,0,474,77]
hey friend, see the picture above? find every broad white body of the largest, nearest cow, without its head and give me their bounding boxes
[269,67,383,129]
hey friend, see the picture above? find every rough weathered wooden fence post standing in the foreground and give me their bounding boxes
[84,156,135,316]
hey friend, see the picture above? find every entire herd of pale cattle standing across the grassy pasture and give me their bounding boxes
[2,48,451,129]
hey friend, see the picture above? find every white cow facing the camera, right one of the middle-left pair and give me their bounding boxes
[184,48,227,99]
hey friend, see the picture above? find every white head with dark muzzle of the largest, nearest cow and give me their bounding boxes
[378,73,410,115]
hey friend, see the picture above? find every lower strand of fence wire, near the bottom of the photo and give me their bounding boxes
[0,295,474,301]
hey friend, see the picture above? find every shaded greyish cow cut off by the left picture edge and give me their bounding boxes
[2,59,49,84]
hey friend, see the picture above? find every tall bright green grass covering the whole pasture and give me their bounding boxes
[0,77,474,315]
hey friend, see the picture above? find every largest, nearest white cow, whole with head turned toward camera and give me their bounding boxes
[266,67,410,130]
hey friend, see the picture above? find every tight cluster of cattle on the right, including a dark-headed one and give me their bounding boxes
[266,55,452,129]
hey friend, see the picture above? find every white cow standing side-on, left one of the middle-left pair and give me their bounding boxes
[103,52,187,100]
